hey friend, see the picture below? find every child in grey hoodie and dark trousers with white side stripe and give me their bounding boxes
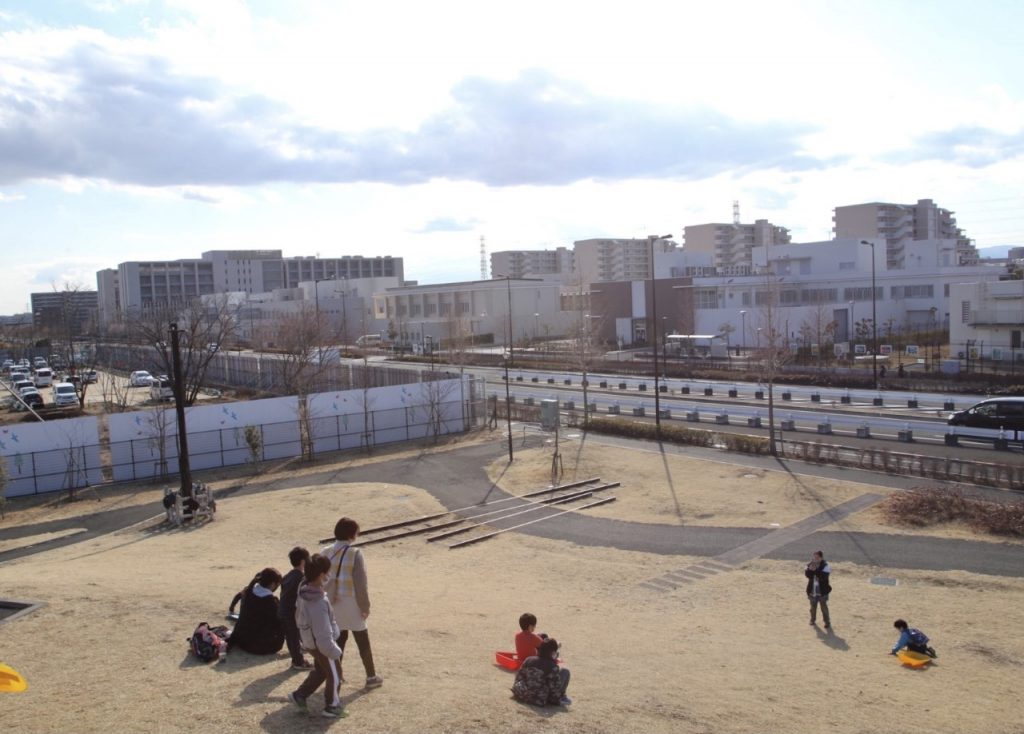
[288,553,348,719]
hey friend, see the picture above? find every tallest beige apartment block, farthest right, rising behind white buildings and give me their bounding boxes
[833,199,978,269]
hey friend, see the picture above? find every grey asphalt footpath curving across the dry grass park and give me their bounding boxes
[0,437,1024,576]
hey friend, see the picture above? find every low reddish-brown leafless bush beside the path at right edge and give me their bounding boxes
[882,488,1024,536]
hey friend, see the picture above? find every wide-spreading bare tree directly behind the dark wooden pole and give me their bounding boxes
[129,295,238,405]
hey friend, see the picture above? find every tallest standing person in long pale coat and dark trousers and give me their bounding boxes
[321,517,384,688]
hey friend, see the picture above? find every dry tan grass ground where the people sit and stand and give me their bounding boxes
[0,432,1024,733]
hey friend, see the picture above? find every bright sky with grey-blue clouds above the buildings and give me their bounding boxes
[0,0,1024,313]
